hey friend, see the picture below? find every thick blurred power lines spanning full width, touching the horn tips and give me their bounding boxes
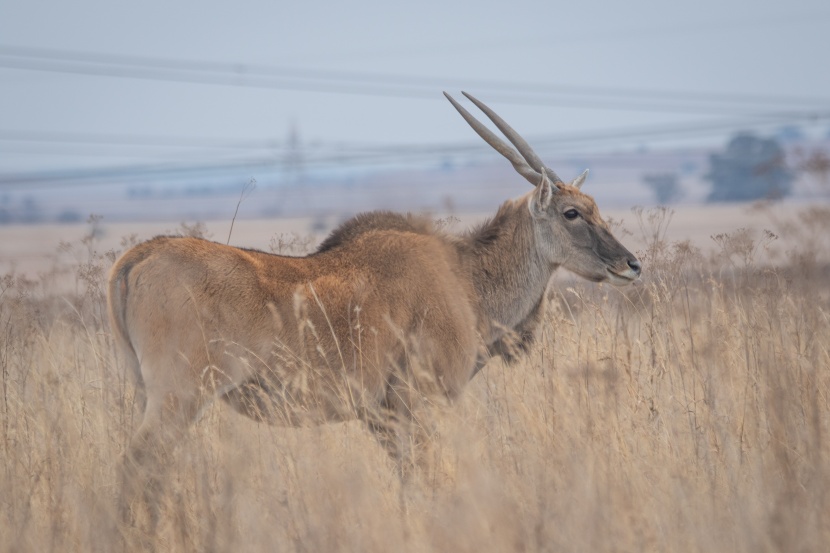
[0,45,830,113]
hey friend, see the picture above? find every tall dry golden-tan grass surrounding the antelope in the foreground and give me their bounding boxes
[0,208,830,552]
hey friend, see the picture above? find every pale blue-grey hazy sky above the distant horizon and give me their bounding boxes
[0,0,830,176]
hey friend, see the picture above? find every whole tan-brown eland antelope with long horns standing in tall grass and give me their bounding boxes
[108,93,640,520]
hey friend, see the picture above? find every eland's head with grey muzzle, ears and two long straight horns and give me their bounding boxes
[444,92,640,286]
